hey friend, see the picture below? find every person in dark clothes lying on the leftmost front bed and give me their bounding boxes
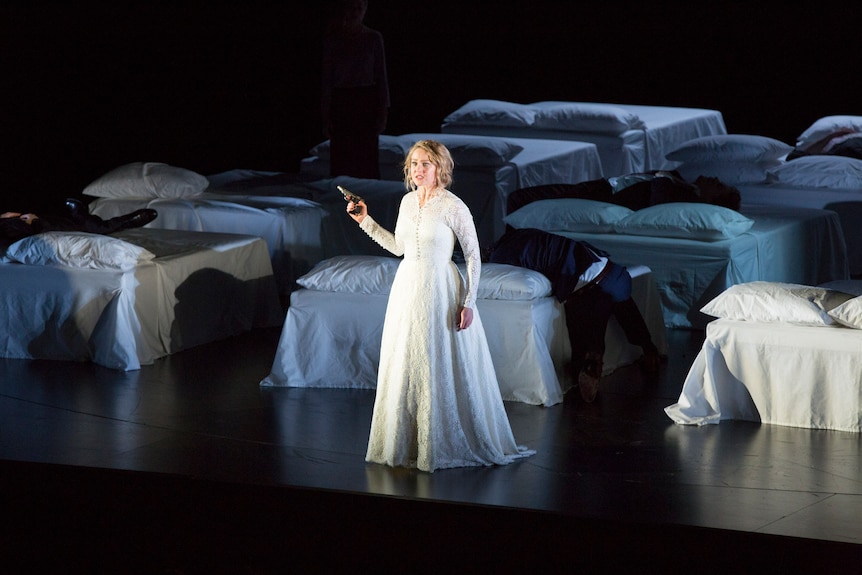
[0,199,158,245]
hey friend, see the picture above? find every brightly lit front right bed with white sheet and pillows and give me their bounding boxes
[665,281,862,432]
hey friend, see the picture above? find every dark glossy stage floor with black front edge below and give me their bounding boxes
[0,329,862,573]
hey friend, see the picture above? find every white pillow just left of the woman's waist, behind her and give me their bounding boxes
[296,255,401,294]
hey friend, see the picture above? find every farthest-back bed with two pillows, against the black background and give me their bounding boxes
[440,99,727,176]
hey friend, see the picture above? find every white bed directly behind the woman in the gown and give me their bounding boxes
[261,256,667,406]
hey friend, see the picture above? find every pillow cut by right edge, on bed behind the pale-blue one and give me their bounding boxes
[766,155,862,190]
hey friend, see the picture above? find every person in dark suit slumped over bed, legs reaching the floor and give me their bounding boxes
[487,228,659,403]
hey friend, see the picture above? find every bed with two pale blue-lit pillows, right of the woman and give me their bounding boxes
[506,185,849,329]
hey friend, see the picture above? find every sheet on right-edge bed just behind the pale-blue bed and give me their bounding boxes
[735,183,862,276]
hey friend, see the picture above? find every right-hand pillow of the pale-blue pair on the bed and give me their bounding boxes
[614,202,754,241]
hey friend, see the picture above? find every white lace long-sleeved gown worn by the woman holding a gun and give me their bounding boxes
[361,190,534,471]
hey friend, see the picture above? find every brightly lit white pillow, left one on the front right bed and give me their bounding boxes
[700,281,853,326]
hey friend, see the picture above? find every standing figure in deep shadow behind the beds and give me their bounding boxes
[321,0,389,179]
